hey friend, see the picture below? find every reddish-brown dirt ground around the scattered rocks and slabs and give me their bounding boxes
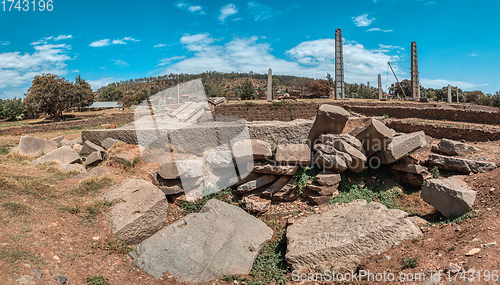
[0,127,500,284]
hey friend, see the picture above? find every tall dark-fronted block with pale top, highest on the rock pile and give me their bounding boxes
[308,104,349,146]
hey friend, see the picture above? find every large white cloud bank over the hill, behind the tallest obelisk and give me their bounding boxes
[159,34,402,82]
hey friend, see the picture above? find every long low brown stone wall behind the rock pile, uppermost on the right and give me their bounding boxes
[214,101,500,125]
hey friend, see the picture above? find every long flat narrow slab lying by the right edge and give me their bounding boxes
[429,154,497,174]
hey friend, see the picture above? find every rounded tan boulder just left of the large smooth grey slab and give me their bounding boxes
[100,179,168,244]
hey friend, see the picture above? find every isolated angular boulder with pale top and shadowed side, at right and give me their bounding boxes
[420,176,476,217]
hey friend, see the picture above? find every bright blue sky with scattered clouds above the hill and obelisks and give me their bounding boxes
[0,0,500,98]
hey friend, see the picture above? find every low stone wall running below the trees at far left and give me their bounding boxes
[0,113,134,135]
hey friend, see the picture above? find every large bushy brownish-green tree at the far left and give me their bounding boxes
[24,73,78,121]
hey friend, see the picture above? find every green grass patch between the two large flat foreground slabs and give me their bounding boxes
[250,216,289,284]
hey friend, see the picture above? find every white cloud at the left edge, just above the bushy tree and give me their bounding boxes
[0,44,71,94]
